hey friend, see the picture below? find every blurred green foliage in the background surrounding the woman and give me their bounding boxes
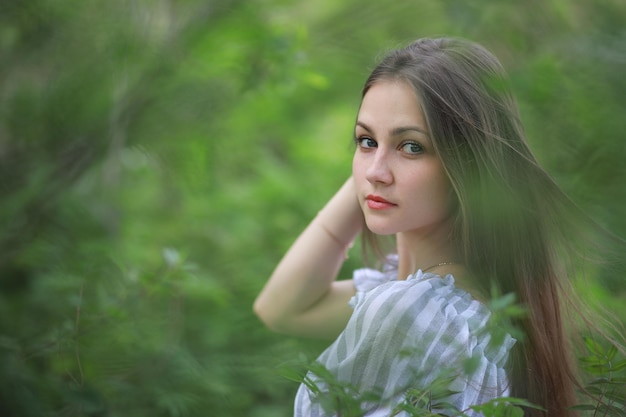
[0,0,626,417]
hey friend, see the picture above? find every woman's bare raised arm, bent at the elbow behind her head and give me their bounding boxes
[254,177,363,338]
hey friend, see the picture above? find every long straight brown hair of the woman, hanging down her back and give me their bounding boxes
[363,38,587,417]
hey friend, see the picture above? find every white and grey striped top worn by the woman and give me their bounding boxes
[294,266,515,417]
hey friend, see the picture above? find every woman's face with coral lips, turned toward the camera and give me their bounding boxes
[352,80,452,235]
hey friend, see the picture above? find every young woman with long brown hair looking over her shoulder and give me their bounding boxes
[254,38,600,417]
